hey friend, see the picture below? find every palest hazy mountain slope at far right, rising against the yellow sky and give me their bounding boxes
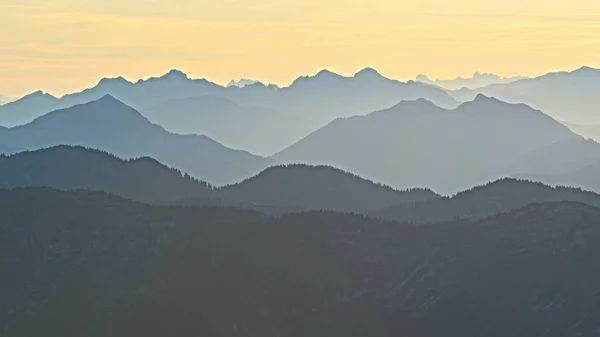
[478,67,600,124]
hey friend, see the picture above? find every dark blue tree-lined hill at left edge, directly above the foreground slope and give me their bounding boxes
[0,145,216,203]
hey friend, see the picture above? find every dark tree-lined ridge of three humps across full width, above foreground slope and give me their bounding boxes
[0,145,600,223]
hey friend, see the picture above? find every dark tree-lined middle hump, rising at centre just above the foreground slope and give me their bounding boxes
[219,165,439,213]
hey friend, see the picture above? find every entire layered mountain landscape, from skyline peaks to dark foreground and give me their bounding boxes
[0,63,600,337]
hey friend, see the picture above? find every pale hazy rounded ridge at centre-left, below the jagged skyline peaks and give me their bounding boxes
[146,96,309,156]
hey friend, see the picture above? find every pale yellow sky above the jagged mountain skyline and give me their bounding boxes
[0,0,600,97]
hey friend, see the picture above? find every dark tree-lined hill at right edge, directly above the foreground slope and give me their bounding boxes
[369,179,600,223]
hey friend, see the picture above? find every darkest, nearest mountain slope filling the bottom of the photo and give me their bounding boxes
[0,189,600,337]
